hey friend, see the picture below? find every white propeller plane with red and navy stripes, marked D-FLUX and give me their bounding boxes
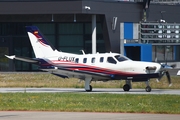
[5,26,173,92]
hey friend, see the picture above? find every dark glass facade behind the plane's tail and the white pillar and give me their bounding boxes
[0,22,105,71]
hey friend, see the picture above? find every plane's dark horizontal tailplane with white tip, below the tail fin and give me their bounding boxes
[5,55,38,64]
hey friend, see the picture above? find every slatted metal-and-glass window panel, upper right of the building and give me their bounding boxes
[140,23,180,43]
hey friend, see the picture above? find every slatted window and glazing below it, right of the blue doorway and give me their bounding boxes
[140,22,180,62]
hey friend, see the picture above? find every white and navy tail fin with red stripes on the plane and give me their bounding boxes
[26,26,55,58]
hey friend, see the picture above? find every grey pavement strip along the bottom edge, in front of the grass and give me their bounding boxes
[0,111,180,120]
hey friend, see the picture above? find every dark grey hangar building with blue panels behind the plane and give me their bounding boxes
[0,0,180,71]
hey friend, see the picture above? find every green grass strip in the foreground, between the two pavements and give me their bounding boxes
[0,93,180,114]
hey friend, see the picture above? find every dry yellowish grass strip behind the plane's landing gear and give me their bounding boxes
[0,73,180,89]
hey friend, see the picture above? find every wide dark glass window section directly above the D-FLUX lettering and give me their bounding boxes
[57,23,84,53]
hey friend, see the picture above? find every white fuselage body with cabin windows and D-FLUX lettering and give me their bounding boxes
[44,53,161,74]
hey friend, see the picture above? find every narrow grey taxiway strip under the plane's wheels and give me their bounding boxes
[0,88,180,95]
